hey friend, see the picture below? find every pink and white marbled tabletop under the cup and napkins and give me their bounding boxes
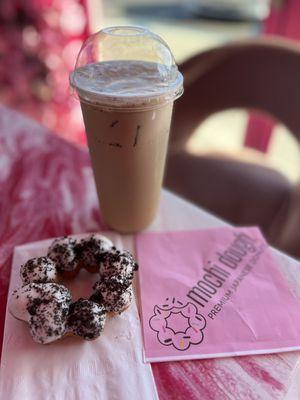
[0,107,300,400]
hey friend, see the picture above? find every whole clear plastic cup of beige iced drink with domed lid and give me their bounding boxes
[70,26,183,233]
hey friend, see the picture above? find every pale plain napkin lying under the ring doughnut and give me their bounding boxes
[0,234,158,400]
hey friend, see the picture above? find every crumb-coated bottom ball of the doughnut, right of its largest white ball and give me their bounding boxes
[68,299,106,340]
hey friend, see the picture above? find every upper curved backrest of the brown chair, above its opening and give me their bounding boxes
[170,37,300,152]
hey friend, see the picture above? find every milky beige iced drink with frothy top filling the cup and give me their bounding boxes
[75,60,181,233]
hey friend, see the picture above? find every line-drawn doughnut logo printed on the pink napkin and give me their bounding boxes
[149,297,206,351]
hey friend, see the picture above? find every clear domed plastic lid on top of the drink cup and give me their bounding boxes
[70,26,183,109]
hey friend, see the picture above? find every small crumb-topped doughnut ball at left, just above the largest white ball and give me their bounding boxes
[20,257,57,285]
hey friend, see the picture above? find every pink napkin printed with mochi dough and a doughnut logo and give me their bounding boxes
[136,227,300,361]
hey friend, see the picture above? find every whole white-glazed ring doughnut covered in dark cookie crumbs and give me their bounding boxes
[9,234,138,344]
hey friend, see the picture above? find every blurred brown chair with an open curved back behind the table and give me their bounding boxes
[165,37,300,257]
